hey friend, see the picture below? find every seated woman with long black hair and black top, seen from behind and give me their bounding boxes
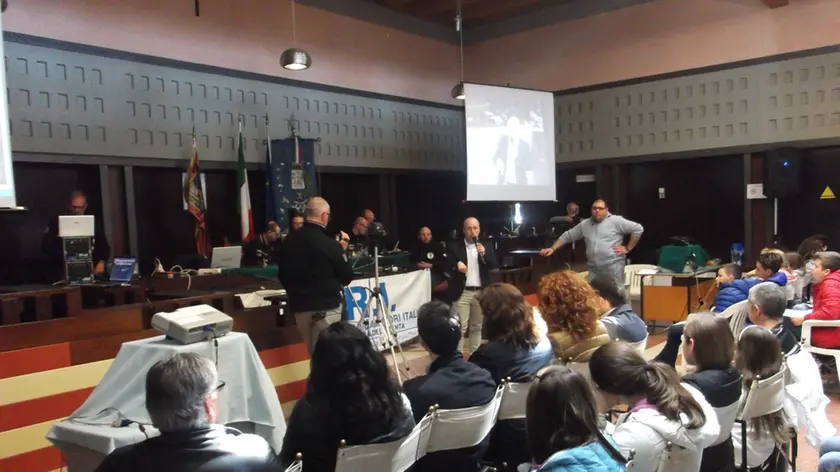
[280,323,414,472]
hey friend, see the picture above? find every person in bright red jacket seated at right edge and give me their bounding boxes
[791,252,840,349]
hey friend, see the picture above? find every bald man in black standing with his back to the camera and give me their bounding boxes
[278,197,353,354]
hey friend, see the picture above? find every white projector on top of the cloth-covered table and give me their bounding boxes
[152,305,233,344]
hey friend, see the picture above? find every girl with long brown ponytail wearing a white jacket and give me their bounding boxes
[589,342,720,472]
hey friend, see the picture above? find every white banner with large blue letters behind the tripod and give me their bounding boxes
[344,269,432,350]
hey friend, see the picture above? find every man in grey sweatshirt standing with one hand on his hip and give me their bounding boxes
[540,200,644,286]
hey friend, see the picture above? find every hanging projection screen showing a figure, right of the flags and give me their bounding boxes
[464,84,556,201]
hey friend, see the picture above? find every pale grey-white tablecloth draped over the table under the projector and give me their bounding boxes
[47,333,286,472]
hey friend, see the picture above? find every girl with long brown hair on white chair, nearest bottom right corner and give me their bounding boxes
[732,326,791,469]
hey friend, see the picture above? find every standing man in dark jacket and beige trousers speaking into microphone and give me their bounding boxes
[446,217,499,352]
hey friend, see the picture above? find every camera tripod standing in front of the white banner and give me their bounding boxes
[350,246,409,385]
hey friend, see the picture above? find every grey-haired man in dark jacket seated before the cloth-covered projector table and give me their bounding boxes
[96,353,275,472]
